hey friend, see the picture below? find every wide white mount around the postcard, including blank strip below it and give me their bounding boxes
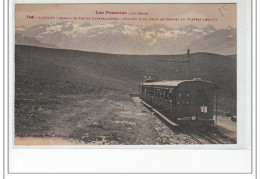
[5,0,254,173]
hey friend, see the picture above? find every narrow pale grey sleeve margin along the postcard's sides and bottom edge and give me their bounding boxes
[9,0,251,149]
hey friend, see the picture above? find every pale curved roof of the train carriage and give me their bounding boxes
[142,79,218,88]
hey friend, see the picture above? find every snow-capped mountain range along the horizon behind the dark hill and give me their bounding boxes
[16,21,236,55]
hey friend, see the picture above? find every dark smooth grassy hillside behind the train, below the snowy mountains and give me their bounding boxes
[15,45,236,112]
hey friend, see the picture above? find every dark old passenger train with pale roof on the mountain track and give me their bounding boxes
[139,78,219,127]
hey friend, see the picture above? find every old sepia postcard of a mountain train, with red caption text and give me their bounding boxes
[13,3,239,146]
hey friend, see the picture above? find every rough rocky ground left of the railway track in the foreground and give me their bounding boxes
[15,75,205,145]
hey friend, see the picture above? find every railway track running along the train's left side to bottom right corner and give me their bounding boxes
[141,101,236,144]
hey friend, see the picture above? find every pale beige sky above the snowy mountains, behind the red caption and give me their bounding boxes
[15,3,237,29]
